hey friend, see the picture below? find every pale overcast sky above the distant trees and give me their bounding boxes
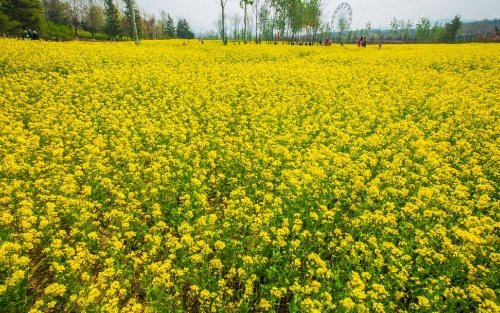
[136,0,500,34]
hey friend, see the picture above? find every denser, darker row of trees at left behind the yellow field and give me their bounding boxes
[0,0,194,39]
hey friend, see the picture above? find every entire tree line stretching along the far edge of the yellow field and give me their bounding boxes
[0,0,500,43]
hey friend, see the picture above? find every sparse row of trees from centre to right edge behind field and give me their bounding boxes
[213,0,500,42]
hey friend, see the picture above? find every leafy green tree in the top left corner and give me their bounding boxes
[0,0,43,36]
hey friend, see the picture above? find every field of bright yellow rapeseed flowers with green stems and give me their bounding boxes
[0,40,500,313]
